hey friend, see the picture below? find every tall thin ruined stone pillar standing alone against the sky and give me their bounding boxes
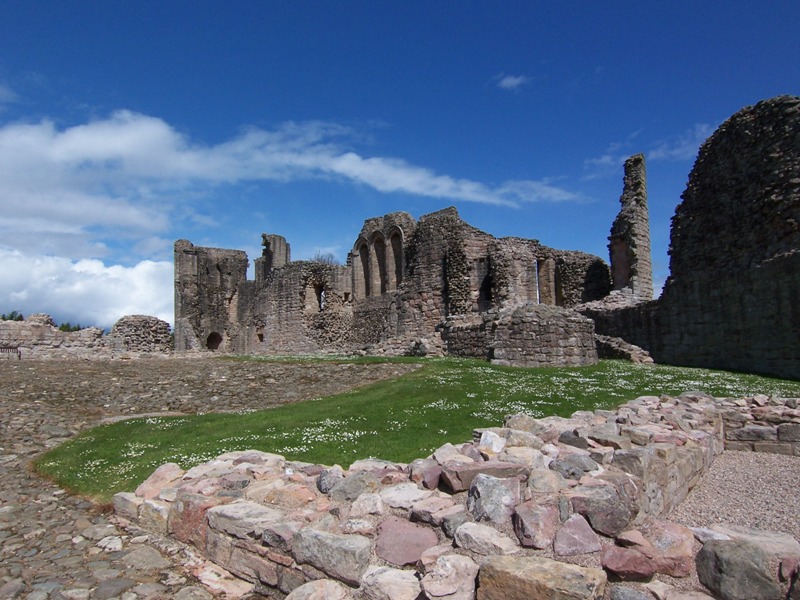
[608,154,653,300]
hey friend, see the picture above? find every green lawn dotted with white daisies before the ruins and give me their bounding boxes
[36,359,800,501]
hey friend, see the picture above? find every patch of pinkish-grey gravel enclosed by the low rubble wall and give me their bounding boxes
[670,452,800,540]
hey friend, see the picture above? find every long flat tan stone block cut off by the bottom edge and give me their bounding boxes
[478,556,606,600]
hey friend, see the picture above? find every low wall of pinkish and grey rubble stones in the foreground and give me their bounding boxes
[114,392,800,599]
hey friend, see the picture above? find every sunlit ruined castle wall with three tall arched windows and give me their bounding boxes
[175,208,610,364]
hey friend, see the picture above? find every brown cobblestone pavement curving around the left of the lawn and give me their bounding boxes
[0,358,414,600]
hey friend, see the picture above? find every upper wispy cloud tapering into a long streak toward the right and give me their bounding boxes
[0,111,580,259]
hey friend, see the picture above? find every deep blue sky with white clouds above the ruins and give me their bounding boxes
[0,0,800,327]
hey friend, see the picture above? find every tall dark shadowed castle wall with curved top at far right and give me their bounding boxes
[579,96,800,379]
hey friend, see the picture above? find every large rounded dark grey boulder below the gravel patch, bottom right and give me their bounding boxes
[696,540,781,600]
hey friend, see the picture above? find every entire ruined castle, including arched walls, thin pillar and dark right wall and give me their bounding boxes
[175,96,800,378]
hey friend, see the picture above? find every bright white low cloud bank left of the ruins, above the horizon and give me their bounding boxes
[0,249,173,329]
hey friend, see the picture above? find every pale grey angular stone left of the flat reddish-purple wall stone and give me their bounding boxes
[292,527,372,585]
